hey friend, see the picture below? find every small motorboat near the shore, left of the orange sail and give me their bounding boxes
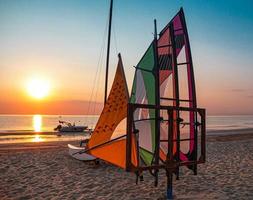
[54,120,92,133]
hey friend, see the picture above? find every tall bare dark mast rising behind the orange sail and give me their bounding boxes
[104,0,113,105]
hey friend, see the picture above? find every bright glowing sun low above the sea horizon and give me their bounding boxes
[27,78,50,99]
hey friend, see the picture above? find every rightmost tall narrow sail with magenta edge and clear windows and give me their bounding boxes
[173,10,196,161]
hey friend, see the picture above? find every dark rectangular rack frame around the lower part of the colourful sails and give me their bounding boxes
[126,103,206,172]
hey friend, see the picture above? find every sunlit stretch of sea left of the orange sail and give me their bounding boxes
[0,115,98,144]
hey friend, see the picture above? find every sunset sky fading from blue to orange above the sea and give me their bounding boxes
[0,0,253,115]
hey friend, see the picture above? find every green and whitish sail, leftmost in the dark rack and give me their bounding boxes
[130,42,155,164]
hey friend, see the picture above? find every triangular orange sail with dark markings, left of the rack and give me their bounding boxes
[88,55,137,169]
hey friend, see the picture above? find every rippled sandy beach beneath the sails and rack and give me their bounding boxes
[0,131,253,200]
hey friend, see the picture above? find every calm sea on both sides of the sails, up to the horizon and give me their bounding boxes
[0,115,253,144]
